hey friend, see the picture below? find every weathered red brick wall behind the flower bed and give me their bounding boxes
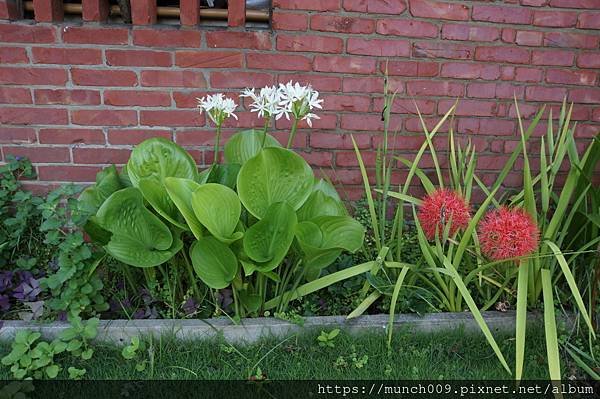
[0,0,600,198]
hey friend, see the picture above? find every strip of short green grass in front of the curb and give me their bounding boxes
[0,328,572,380]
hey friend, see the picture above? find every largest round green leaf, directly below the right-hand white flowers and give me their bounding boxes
[237,147,314,219]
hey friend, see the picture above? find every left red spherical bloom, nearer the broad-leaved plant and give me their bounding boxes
[418,189,471,240]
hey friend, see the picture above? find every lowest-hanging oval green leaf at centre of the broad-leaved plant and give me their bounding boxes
[190,237,238,289]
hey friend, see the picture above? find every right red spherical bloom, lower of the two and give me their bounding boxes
[479,207,540,260]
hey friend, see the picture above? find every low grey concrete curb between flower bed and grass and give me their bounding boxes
[0,311,520,344]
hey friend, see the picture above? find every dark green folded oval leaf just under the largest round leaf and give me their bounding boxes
[244,202,297,272]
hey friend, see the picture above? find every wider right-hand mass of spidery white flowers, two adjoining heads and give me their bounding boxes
[241,81,323,127]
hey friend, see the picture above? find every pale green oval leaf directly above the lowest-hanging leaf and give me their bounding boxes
[192,183,243,244]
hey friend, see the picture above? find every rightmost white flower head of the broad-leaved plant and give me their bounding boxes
[279,81,323,126]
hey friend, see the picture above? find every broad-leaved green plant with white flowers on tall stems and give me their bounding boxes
[80,86,364,317]
